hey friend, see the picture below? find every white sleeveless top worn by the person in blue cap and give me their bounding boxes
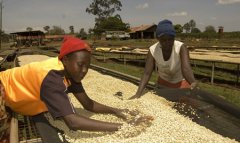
[149,40,184,83]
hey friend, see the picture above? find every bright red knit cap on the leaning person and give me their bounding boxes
[58,36,91,60]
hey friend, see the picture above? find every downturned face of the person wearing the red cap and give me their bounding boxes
[62,50,91,82]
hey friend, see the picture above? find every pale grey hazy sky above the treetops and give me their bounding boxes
[2,0,240,33]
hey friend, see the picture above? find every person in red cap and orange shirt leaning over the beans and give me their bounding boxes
[0,36,150,143]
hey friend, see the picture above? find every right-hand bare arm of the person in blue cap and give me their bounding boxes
[180,45,196,84]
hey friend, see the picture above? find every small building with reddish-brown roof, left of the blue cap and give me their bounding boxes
[129,24,157,39]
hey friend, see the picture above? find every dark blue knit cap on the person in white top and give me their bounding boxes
[156,19,176,37]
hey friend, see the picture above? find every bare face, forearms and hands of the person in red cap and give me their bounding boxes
[62,50,148,131]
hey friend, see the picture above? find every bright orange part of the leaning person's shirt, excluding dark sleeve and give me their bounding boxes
[0,58,64,115]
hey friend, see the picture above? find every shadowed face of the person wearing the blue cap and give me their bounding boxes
[158,35,175,48]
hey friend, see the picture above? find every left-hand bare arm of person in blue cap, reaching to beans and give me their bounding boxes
[130,51,155,99]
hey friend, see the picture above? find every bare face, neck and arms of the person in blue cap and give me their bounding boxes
[130,35,196,99]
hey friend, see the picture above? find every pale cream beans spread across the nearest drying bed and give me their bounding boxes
[17,55,236,143]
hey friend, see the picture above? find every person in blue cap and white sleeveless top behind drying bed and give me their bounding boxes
[130,20,197,99]
